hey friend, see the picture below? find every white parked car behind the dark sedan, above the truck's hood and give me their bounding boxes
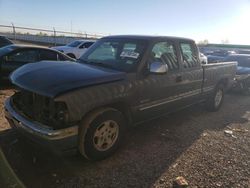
[52,40,95,59]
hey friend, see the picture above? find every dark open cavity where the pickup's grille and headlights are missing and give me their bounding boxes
[11,90,69,129]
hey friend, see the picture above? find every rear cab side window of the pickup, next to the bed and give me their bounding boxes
[180,43,199,68]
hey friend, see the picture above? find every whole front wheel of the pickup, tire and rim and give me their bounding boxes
[78,108,125,160]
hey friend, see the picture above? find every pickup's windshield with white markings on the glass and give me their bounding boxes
[80,39,146,72]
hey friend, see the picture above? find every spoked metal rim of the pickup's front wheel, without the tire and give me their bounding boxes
[93,120,119,151]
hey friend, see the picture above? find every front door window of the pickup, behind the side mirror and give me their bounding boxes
[150,42,179,71]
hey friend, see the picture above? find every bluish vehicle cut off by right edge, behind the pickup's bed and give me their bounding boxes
[225,54,250,95]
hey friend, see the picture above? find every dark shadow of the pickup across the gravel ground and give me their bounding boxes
[0,94,250,187]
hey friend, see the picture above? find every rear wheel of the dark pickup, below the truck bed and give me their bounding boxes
[207,84,224,112]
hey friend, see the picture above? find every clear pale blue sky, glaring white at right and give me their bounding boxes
[0,0,250,45]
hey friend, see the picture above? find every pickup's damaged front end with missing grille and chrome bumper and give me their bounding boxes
[5,90,78,152]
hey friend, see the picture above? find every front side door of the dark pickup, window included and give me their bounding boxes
[136,40,185,121]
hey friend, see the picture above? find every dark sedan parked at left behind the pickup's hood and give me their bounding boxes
[0,44,74,80]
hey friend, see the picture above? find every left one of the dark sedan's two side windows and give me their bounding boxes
[5,49,38,63]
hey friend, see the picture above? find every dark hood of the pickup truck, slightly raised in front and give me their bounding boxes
[10,61,126,97]
